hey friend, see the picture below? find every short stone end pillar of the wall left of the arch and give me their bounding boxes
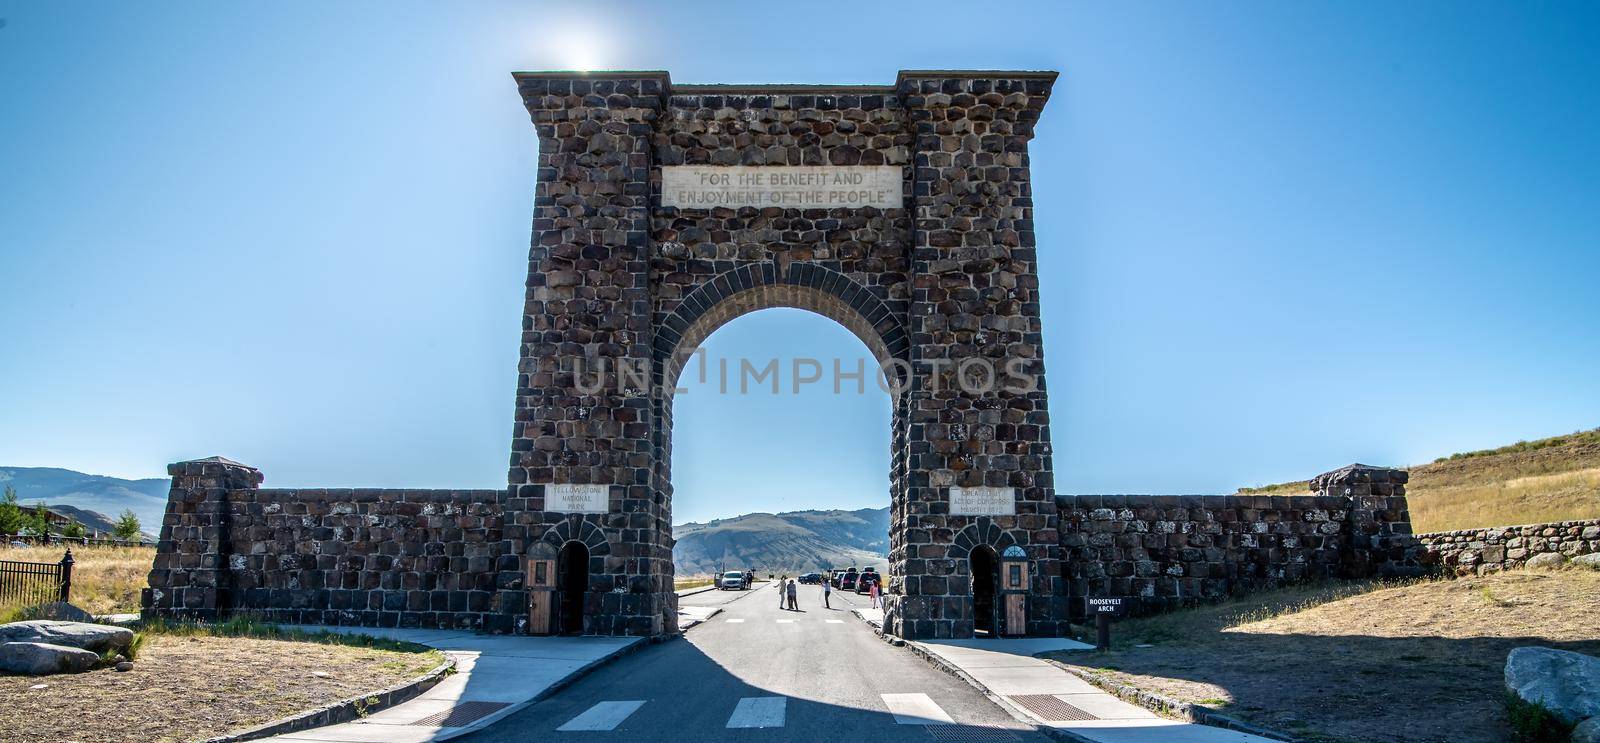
[139,456,261,620]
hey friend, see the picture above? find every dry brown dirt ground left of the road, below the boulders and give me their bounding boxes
[0,634,443,743]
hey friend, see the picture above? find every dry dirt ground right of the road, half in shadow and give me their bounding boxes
[1056,570,1600,743]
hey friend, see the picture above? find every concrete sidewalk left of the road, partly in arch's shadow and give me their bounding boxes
[266,626,646,743]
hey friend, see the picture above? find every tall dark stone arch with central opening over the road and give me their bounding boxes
[506,70,1067,637]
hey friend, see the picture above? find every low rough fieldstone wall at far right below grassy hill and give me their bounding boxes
[1418,519,1600,575]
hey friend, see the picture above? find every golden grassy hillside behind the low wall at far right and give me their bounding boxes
[1238,429,1600,533]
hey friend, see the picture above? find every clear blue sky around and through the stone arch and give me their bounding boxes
[0,2,1600,520]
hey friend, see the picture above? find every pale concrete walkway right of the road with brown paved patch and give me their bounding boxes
[854,607,1275,743]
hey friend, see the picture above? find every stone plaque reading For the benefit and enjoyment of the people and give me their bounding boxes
[661,165,902,208]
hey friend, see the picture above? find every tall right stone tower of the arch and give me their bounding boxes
[886,72,1067,637]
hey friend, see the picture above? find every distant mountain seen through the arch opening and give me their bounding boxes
[672,508,890,576]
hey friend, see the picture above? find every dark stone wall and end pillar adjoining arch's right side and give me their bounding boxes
[1056,466,1421,616]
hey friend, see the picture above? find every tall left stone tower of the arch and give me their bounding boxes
[502,72,677,636]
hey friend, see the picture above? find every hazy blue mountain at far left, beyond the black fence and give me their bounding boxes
[0,468,171,535]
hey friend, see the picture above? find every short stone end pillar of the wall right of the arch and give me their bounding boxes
[1310,464,1422,578]
